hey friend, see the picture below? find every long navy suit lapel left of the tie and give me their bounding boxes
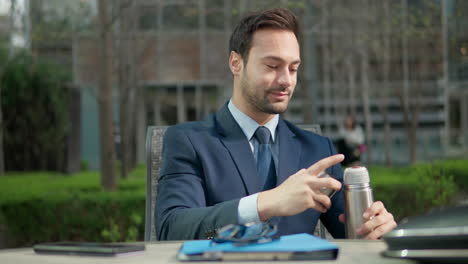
[216,104,261,195]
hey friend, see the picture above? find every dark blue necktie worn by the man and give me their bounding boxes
[255,126,276,190]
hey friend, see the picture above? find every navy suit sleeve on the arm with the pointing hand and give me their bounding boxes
[155,126,239,240]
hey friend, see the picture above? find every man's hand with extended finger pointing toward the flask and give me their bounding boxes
[257,154,344,221]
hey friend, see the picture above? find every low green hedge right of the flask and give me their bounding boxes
[369,160,468,221]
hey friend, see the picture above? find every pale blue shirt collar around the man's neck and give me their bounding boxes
[228,99,279,142]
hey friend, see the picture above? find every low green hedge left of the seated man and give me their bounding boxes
[0,168,146,247]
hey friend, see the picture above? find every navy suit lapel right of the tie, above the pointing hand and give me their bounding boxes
[276,118,302,185]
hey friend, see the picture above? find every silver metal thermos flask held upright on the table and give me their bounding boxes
[344,166,374,239]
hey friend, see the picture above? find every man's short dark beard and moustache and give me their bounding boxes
[241,75,291,114]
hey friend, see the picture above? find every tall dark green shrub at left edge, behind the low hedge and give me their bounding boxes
[0,52,70,171]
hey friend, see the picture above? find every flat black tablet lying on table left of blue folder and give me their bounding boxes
[34,242,145,256]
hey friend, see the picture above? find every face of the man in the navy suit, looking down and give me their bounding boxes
[239,29,300,114]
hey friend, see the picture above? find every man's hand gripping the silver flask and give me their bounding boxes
[339,201,397,239]
